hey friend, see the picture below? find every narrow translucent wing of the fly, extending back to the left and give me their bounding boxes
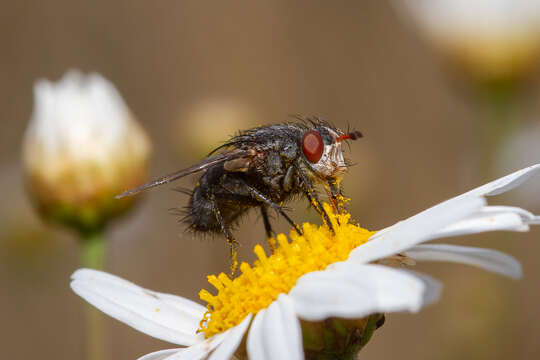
[116,150,255,199]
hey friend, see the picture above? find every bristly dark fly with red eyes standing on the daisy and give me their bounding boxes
[117,117,362,274]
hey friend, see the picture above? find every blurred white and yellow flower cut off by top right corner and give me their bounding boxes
[395,0,540,80]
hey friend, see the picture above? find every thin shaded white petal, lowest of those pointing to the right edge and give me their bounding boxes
[405,244,521,279]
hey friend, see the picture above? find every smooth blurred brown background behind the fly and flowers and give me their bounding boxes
[0,0,540,360]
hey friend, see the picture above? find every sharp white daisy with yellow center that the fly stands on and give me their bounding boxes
[71,164,540,360]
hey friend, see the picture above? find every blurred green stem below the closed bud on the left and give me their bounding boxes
[81,230,106,360]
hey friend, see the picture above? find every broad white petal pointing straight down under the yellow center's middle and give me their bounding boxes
[247,294,304,360]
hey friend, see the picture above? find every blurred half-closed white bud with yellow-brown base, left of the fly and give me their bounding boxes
[23,70,151,232]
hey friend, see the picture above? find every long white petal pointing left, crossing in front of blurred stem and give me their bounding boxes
[71,269,206,345]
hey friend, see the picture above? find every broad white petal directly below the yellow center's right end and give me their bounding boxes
[289,261,426,321]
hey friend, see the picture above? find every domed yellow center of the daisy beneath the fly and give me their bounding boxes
[199,204,375,338]
